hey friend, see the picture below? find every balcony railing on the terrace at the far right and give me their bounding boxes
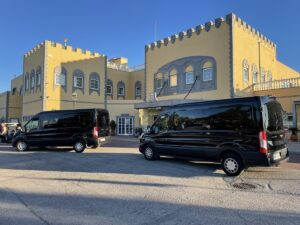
[253,77,300,91]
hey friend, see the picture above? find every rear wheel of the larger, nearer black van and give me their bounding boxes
[221,153,245,177]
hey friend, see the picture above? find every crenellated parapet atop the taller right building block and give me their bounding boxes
[145,13,276,51]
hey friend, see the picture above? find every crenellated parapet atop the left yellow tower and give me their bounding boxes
[24,40,105,58]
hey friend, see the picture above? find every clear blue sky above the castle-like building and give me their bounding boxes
[0,0,300,92]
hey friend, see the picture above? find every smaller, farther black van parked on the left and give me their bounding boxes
[12,109,110,153]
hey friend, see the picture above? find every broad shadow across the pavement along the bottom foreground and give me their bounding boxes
[0,189,300,225]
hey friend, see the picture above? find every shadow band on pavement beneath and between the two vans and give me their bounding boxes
[0,149,224,177]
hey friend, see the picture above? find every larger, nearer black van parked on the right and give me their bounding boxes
[139,96,289,176]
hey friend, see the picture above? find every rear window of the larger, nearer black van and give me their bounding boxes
[265,100,283,131]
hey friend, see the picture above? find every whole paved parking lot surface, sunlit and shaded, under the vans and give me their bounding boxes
[0,137,300,225]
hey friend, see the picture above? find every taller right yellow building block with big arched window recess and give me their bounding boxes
[135,14,300,128]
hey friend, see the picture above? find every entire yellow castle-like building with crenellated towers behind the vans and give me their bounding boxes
[0,14,300,132]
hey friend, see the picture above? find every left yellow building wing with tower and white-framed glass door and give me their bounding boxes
[22,41,144,135]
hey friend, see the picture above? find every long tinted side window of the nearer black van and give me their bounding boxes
[172,104,254,130]
